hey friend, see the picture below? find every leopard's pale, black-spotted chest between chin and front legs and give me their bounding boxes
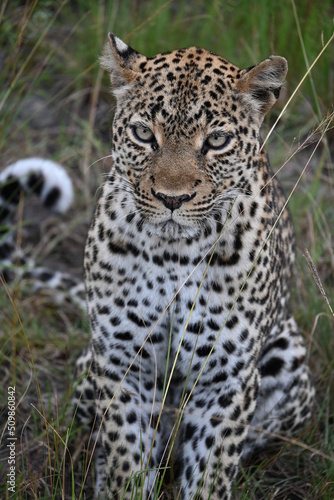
[86,190,280,381]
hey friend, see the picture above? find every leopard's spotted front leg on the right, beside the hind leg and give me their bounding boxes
[177,366,258,500]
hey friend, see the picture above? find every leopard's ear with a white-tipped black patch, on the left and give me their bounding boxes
[100,33,146,95]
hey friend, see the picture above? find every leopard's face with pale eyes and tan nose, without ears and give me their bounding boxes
[105,41,288,238]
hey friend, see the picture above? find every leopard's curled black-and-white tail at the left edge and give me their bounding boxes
[0,157,86,306]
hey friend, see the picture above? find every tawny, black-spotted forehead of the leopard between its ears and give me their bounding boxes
[132,47,241,126]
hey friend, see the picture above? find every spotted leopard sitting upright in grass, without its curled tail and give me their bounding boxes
[77,33,315,500]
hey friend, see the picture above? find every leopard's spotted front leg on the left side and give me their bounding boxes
[95,364,168,499]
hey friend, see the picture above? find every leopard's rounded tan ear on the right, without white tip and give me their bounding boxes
[237,56,288,116]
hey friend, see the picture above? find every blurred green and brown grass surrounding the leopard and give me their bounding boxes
[0,0,334,500]
